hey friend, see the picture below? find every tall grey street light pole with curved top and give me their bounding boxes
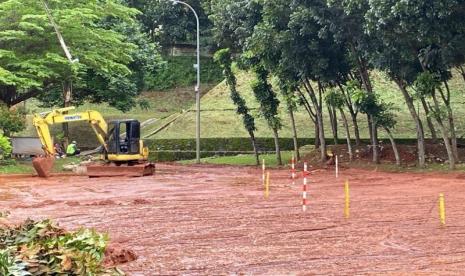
[169,0,200,164]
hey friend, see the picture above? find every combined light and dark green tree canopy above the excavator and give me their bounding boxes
[0,0,159,111]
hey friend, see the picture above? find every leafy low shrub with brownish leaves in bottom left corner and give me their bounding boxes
[0,220,124,276]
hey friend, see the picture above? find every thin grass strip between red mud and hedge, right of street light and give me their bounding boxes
[178,151,300,167]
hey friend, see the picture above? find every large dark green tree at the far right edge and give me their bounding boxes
[366,0,465,168]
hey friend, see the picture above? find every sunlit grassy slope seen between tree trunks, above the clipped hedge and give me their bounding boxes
[154,72,465,139]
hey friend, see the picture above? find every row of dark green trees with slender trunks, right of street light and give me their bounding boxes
[205,0,465,168]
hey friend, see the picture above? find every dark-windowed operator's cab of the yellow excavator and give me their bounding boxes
[107,120,141,155]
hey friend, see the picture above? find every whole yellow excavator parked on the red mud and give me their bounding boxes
[32,107,155,177]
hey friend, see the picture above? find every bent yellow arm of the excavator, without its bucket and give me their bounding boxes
[33,107,108,156]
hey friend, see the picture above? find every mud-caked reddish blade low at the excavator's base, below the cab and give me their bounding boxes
[87,163,155,177]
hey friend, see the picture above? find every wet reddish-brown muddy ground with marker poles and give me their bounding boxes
[0,165,465,275]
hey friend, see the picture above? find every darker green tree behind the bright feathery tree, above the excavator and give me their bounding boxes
[38,21,162,112]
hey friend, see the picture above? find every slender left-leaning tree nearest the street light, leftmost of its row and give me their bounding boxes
[214,49,260,166]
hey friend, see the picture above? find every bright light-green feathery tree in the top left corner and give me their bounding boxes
[0,0,145,106]
